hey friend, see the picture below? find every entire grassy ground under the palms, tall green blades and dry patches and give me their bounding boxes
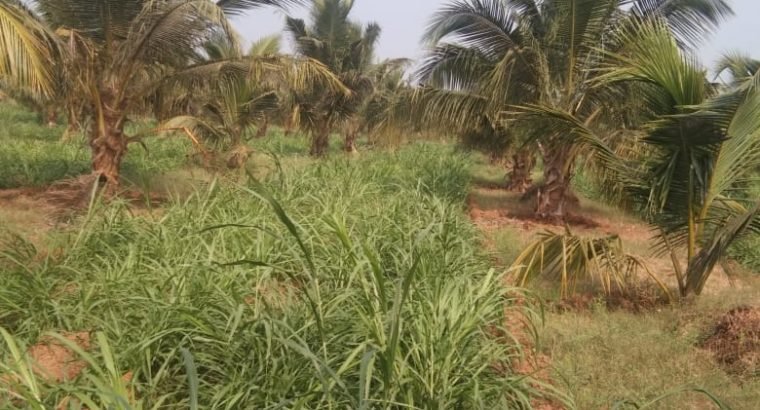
[0,101,760,410]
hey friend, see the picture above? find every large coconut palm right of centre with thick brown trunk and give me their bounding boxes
[426,0,730,219]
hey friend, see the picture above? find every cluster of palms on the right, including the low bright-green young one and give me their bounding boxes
[416,0,760,295]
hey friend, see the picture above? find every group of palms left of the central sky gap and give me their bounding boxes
[0,0,407,173]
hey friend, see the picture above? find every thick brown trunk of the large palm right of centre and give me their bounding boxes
[536,144,572,221]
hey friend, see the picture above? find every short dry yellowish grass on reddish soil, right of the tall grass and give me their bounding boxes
[471,159,760,410]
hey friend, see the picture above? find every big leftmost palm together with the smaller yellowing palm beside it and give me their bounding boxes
[0,0,360,187]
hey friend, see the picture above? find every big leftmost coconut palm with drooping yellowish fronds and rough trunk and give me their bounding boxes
[0,0,302,188]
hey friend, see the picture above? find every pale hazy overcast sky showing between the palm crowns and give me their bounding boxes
[236,0,760,73]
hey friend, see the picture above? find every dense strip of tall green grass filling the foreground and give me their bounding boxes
[0,145,552,409]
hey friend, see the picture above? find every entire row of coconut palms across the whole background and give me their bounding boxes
[0,0,760,294]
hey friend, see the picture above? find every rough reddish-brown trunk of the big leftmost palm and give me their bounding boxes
[90,91,128,191]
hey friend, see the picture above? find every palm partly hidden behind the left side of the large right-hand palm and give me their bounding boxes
[416,2,538,192]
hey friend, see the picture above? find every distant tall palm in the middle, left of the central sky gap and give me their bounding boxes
[286,0,381,156]
